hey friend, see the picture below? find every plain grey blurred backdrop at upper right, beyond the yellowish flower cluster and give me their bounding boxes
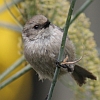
[75,0,100,53]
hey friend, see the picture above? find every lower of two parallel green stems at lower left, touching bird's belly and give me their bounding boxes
[0,65,32,89]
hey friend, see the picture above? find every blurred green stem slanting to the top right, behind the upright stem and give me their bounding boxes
[70,0,93,24]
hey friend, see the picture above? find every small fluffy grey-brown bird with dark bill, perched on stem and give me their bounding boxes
[22,15,96,86]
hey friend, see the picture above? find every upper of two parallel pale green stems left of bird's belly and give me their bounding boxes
[0,56,25,80]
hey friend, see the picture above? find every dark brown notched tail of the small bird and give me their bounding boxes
[72,65,96,86]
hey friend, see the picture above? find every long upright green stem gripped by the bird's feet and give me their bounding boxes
[47,0,76,100]
